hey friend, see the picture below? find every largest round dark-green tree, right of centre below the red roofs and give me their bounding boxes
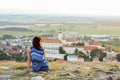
[90,48,107,61]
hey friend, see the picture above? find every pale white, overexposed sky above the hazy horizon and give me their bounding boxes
[0,0,120,16]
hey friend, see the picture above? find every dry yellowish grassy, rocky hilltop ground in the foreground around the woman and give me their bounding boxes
[0,61,120,80]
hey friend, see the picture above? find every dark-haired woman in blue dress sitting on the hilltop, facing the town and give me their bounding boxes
[27,37,49,72]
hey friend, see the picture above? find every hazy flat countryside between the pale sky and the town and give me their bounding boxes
[0,15,120,37]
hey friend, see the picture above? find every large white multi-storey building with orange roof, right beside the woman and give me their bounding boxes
[42,38,64,59]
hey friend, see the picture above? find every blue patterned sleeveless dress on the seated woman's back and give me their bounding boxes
[30,47,49,71]
